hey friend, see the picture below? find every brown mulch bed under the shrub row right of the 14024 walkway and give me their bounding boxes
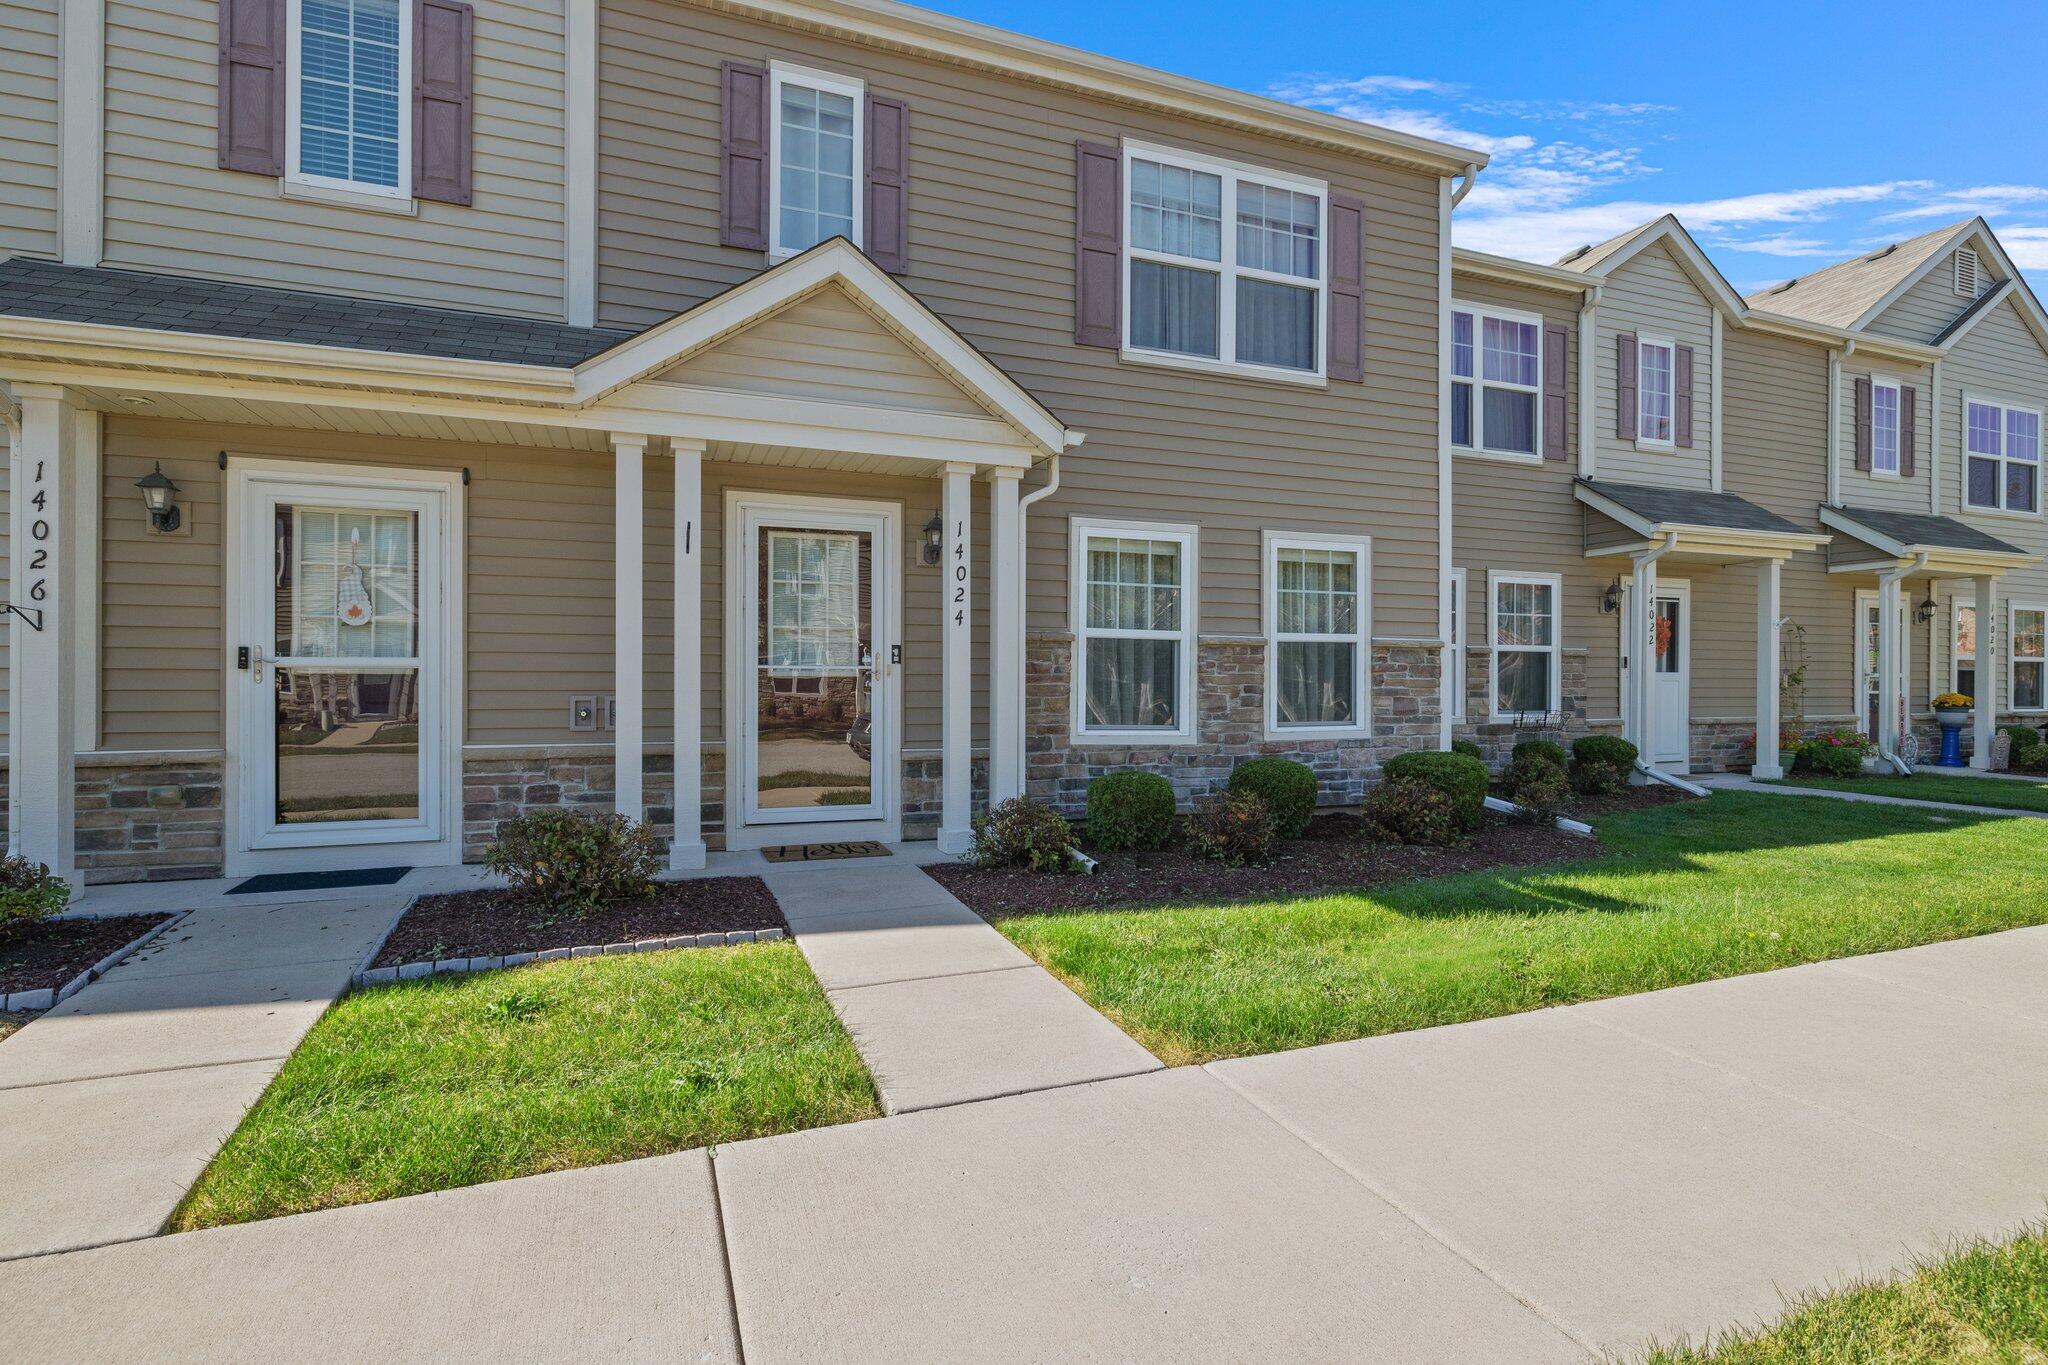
[926,802,1613,917]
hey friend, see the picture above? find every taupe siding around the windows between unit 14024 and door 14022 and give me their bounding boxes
[1452,274,1622,726]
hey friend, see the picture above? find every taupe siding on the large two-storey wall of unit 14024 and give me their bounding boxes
[598,0,1438,639]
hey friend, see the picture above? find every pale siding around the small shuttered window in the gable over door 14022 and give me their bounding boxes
[1593,241,1714,489]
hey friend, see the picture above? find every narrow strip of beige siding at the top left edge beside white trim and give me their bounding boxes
[0,0,57,256]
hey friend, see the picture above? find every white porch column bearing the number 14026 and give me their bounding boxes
[6,385,82,888]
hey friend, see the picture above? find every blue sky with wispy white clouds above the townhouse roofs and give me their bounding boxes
[934,0,2048,293]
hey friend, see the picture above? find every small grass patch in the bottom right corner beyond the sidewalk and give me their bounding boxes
[1649,1228,2048,1365]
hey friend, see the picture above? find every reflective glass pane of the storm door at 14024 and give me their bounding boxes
[754,528,874,819]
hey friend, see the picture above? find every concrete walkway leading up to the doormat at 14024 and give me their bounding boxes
[760,845,1159,1113]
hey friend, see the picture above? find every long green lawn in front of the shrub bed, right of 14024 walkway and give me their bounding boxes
[997,792,2048,1064]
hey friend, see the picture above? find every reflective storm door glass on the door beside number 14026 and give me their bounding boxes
[274,505,420,825]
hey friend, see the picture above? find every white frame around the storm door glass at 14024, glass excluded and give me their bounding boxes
[723,489,903,849]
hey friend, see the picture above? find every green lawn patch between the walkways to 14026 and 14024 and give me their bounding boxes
[172,941,881,1230]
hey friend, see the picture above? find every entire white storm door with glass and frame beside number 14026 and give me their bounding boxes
[227,460,461,876]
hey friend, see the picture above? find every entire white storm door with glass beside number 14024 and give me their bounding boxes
[727,493,901,847]
